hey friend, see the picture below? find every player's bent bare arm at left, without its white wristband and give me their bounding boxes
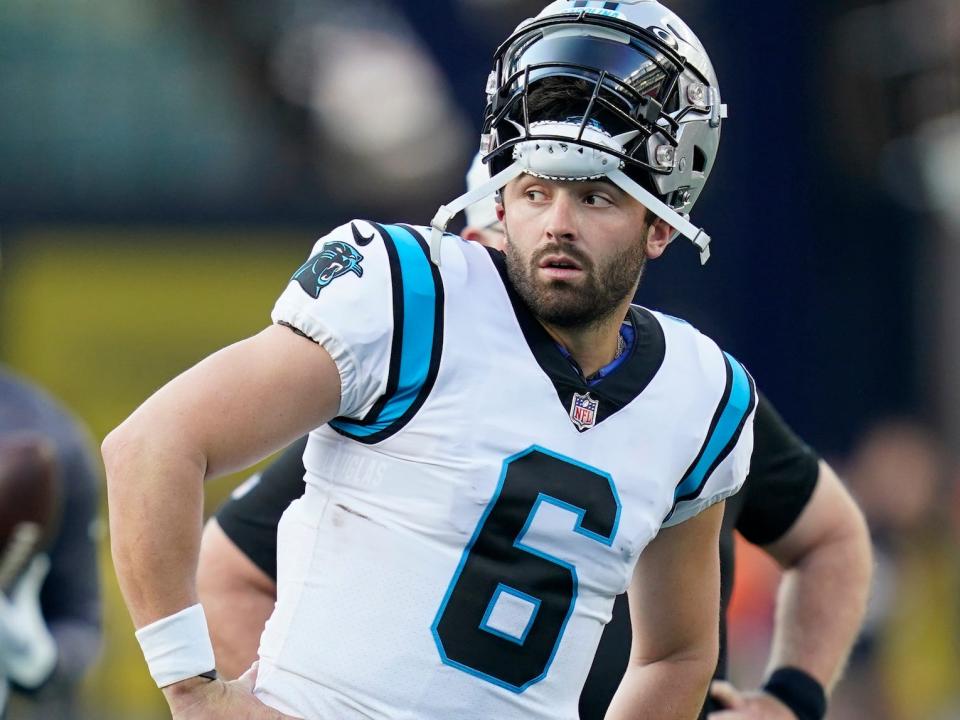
[103,325,340,716]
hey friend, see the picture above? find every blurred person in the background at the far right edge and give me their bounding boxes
[836,420,960,720]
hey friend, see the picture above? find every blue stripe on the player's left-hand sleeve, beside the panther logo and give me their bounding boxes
[330,225,437,438]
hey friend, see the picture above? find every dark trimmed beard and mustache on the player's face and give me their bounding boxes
[505,223,647,328]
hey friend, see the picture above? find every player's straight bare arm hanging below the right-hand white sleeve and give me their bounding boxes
[606,503,723,720]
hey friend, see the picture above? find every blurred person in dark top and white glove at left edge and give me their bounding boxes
[0,334,101,720]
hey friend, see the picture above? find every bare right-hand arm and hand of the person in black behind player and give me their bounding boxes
[710,461,872,720]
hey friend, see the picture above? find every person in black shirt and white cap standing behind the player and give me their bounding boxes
[197,155,871,720]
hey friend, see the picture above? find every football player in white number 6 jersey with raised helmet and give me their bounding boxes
[103,0,784,720]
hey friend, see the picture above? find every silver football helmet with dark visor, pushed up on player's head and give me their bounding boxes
[432,0,726,263]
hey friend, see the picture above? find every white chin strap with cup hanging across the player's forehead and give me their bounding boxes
[430,121,710,265]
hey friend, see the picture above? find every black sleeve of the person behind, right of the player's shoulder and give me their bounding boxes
[737,393,820,545]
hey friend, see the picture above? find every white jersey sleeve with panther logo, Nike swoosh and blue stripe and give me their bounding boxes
[273,220,444,443]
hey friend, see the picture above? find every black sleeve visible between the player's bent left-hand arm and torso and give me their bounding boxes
[216,437,307,581]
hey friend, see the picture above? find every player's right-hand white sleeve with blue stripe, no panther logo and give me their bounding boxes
[663,342,757,527]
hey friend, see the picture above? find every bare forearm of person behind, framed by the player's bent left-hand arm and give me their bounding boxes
[197,518,277,679]
